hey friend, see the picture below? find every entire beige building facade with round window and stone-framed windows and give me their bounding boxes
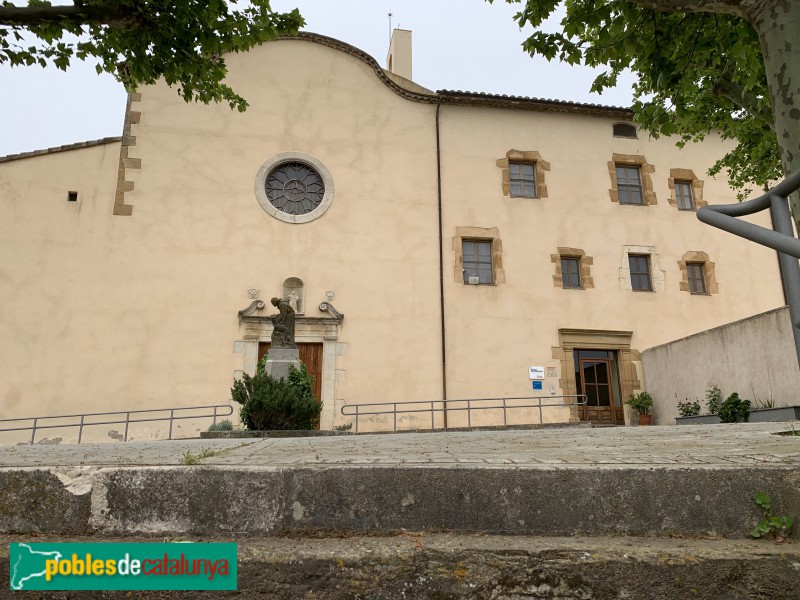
[0,34,784,437]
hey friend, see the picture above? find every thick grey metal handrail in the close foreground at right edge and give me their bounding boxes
[697,171,800,365]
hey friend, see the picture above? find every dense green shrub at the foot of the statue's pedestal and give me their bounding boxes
[231,365,322,430]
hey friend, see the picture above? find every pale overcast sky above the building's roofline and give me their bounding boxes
[0,0,633,156]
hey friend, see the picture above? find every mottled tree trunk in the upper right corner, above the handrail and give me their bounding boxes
[747,0,800,231]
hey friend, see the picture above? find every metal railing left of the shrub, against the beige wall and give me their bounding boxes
[0,404,233,444]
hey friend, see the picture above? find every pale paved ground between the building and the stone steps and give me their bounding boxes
[0,423,800,468]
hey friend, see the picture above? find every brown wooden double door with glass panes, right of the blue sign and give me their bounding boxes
[573,350,625,425]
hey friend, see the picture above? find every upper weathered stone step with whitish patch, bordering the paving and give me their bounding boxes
[0,464,800,538]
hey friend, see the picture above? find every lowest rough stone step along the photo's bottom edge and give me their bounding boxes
[0,532,800,600]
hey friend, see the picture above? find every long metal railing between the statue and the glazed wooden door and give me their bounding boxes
[341,394,587,433]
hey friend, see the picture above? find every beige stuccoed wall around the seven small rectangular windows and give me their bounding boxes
[441,106,783,408]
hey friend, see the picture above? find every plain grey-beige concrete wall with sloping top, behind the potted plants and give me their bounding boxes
[642,307,800,425]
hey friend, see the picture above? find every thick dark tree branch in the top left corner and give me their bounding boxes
[0,5,137,29]
